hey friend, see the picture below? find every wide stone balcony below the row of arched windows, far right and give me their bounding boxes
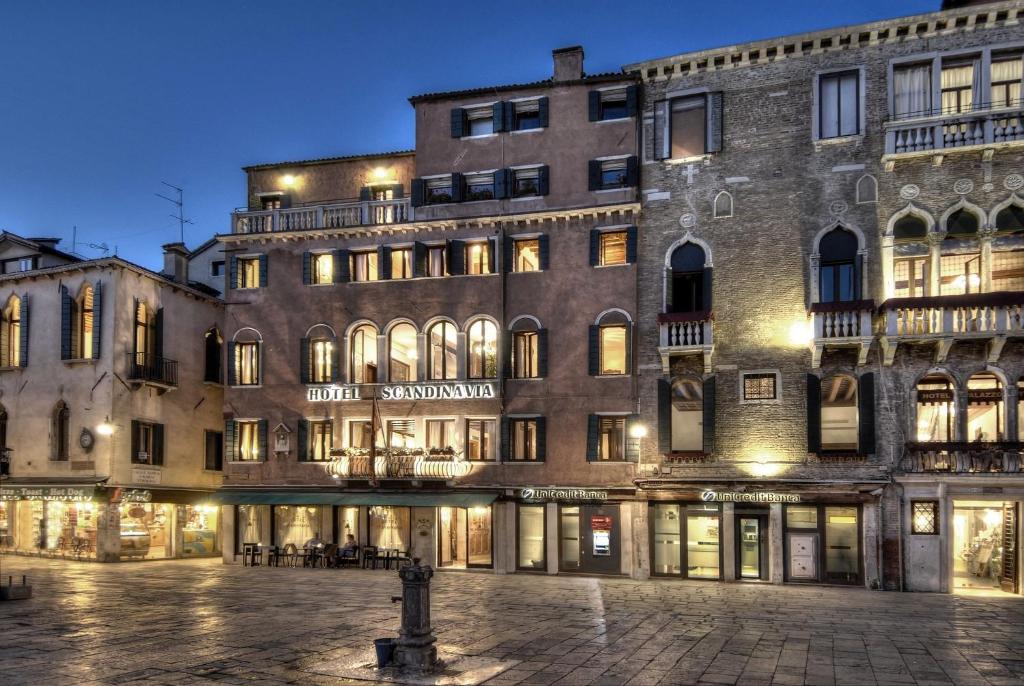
[880,292,1024,366]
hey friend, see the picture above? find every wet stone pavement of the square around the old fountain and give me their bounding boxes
[0,556,1024,686]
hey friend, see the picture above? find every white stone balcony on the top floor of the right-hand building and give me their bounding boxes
[882,102,1024,171]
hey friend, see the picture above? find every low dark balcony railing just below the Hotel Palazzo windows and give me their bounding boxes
[899,441,1024,474]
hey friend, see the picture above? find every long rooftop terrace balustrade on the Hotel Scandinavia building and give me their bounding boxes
[231,198,412,233]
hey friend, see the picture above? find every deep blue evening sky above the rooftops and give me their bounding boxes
[0,0,939,267]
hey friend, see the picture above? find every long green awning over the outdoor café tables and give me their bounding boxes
[211,490,498,508]
